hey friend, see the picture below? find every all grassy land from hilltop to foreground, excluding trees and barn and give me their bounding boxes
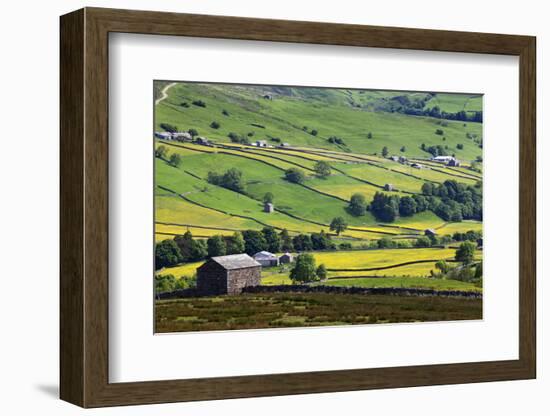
[154,82,483,332]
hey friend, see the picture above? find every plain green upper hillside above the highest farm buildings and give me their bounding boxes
[155,83,482,161]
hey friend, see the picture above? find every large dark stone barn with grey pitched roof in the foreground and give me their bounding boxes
[197,254,262,295]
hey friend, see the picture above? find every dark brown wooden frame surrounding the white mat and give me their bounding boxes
[60,8,536,407]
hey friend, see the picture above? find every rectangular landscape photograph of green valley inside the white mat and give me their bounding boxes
[153,80,483,333]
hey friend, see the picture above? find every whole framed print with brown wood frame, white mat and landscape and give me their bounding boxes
[60,8,536,407]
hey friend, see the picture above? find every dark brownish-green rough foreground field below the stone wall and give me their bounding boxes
[155,293,482,332]
